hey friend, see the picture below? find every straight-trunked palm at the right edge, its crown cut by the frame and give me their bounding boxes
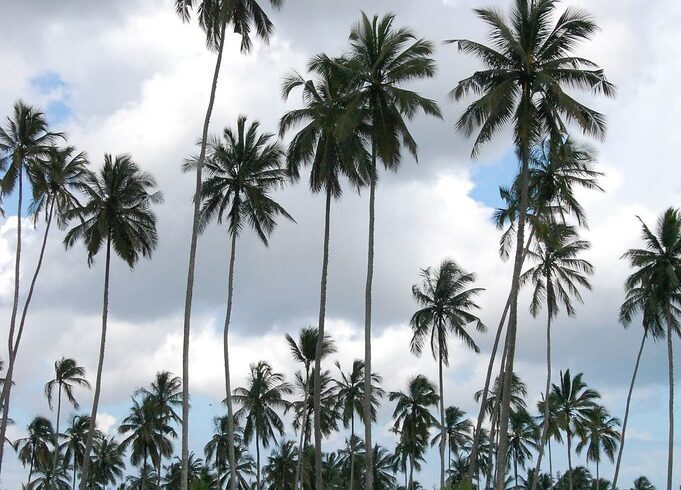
[623,208,681,490]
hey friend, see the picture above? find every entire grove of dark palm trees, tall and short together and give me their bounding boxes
[0,0,681,490]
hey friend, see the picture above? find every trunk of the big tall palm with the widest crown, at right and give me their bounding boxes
[496,139,529,490]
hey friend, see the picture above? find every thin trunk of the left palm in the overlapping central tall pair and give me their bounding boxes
[314,187,331,490]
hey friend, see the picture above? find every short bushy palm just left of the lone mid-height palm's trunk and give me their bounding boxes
[390,374,439,490]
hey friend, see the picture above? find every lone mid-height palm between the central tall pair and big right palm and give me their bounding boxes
[410,259,487,488]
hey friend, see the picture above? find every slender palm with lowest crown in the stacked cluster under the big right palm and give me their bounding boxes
[520,221,593,488]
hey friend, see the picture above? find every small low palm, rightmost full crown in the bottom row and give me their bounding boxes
[577,405,620,490]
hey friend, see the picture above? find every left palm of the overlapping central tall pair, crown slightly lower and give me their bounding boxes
[279,60,369,488]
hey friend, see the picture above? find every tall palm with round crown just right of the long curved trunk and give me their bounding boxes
[189,116,293,486]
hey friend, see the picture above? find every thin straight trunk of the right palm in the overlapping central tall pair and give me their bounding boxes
[364,147,377,490]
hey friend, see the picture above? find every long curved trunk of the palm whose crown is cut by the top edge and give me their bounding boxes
[180,20,225,490]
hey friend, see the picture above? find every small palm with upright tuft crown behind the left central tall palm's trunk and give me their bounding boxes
[286,327,336,489]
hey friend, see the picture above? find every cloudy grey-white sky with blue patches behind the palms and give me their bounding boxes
[0,0,681,488]
